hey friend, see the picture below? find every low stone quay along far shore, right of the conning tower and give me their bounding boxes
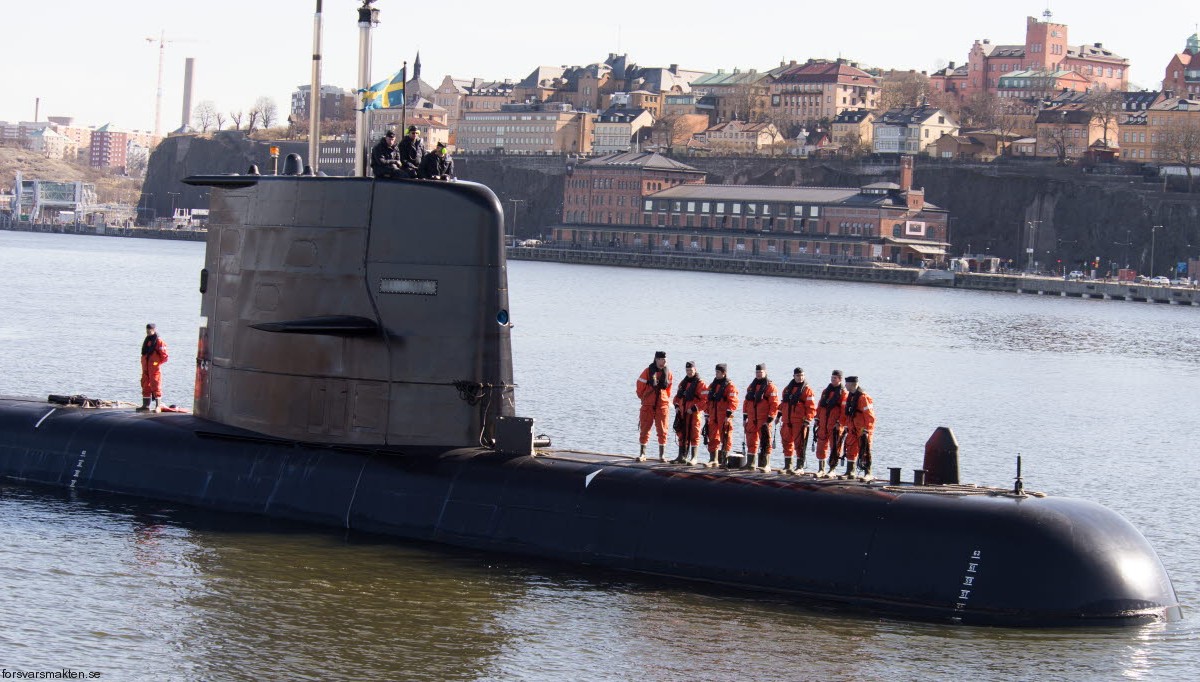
[509,246,1200,306]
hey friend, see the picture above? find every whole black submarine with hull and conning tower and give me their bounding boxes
[0,2,1182,627]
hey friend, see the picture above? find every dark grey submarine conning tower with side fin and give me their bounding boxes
[185,174,514,448]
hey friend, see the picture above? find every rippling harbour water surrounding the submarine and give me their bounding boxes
[0,232,1200,681]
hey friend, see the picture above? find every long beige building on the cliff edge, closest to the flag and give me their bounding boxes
[457,102,596,154]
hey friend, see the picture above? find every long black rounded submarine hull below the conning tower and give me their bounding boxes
[0,399,1181,627]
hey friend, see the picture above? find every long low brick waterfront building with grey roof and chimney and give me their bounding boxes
[551,156,949,264]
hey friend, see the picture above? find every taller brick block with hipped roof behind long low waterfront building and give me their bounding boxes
[563,151,704,225]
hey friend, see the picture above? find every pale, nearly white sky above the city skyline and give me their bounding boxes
[0,0,1200,132]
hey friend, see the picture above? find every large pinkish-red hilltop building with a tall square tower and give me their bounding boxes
[932,10,1129,98]
